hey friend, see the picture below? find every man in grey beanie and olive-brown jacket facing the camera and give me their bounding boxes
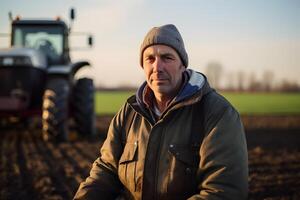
[75,24,248,200]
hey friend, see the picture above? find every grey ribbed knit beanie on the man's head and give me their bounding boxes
[140,24,189,67]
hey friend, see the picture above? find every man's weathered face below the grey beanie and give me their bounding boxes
[143,45,185,97]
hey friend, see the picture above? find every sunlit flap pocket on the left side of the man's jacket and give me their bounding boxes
[118,141,138,191]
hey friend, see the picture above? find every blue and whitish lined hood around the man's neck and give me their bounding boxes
[136,69,212,108]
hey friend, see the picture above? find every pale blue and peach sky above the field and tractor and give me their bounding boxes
[0,0,300,87]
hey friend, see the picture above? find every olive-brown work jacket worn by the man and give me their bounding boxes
[74,71,248,200]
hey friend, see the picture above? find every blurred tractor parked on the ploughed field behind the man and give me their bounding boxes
[0,9,95,142]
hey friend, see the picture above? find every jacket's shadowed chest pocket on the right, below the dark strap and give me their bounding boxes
[167,144,199,195]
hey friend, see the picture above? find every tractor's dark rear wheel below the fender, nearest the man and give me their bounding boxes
[72,78,96,136]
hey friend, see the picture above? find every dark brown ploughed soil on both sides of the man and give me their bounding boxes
[0,116,300,200]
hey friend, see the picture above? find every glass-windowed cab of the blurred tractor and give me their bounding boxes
[11,18,70,66]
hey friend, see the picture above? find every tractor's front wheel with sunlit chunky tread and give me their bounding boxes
[42,78,70,142]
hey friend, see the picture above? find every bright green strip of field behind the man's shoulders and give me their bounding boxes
[95,91,300,115]
